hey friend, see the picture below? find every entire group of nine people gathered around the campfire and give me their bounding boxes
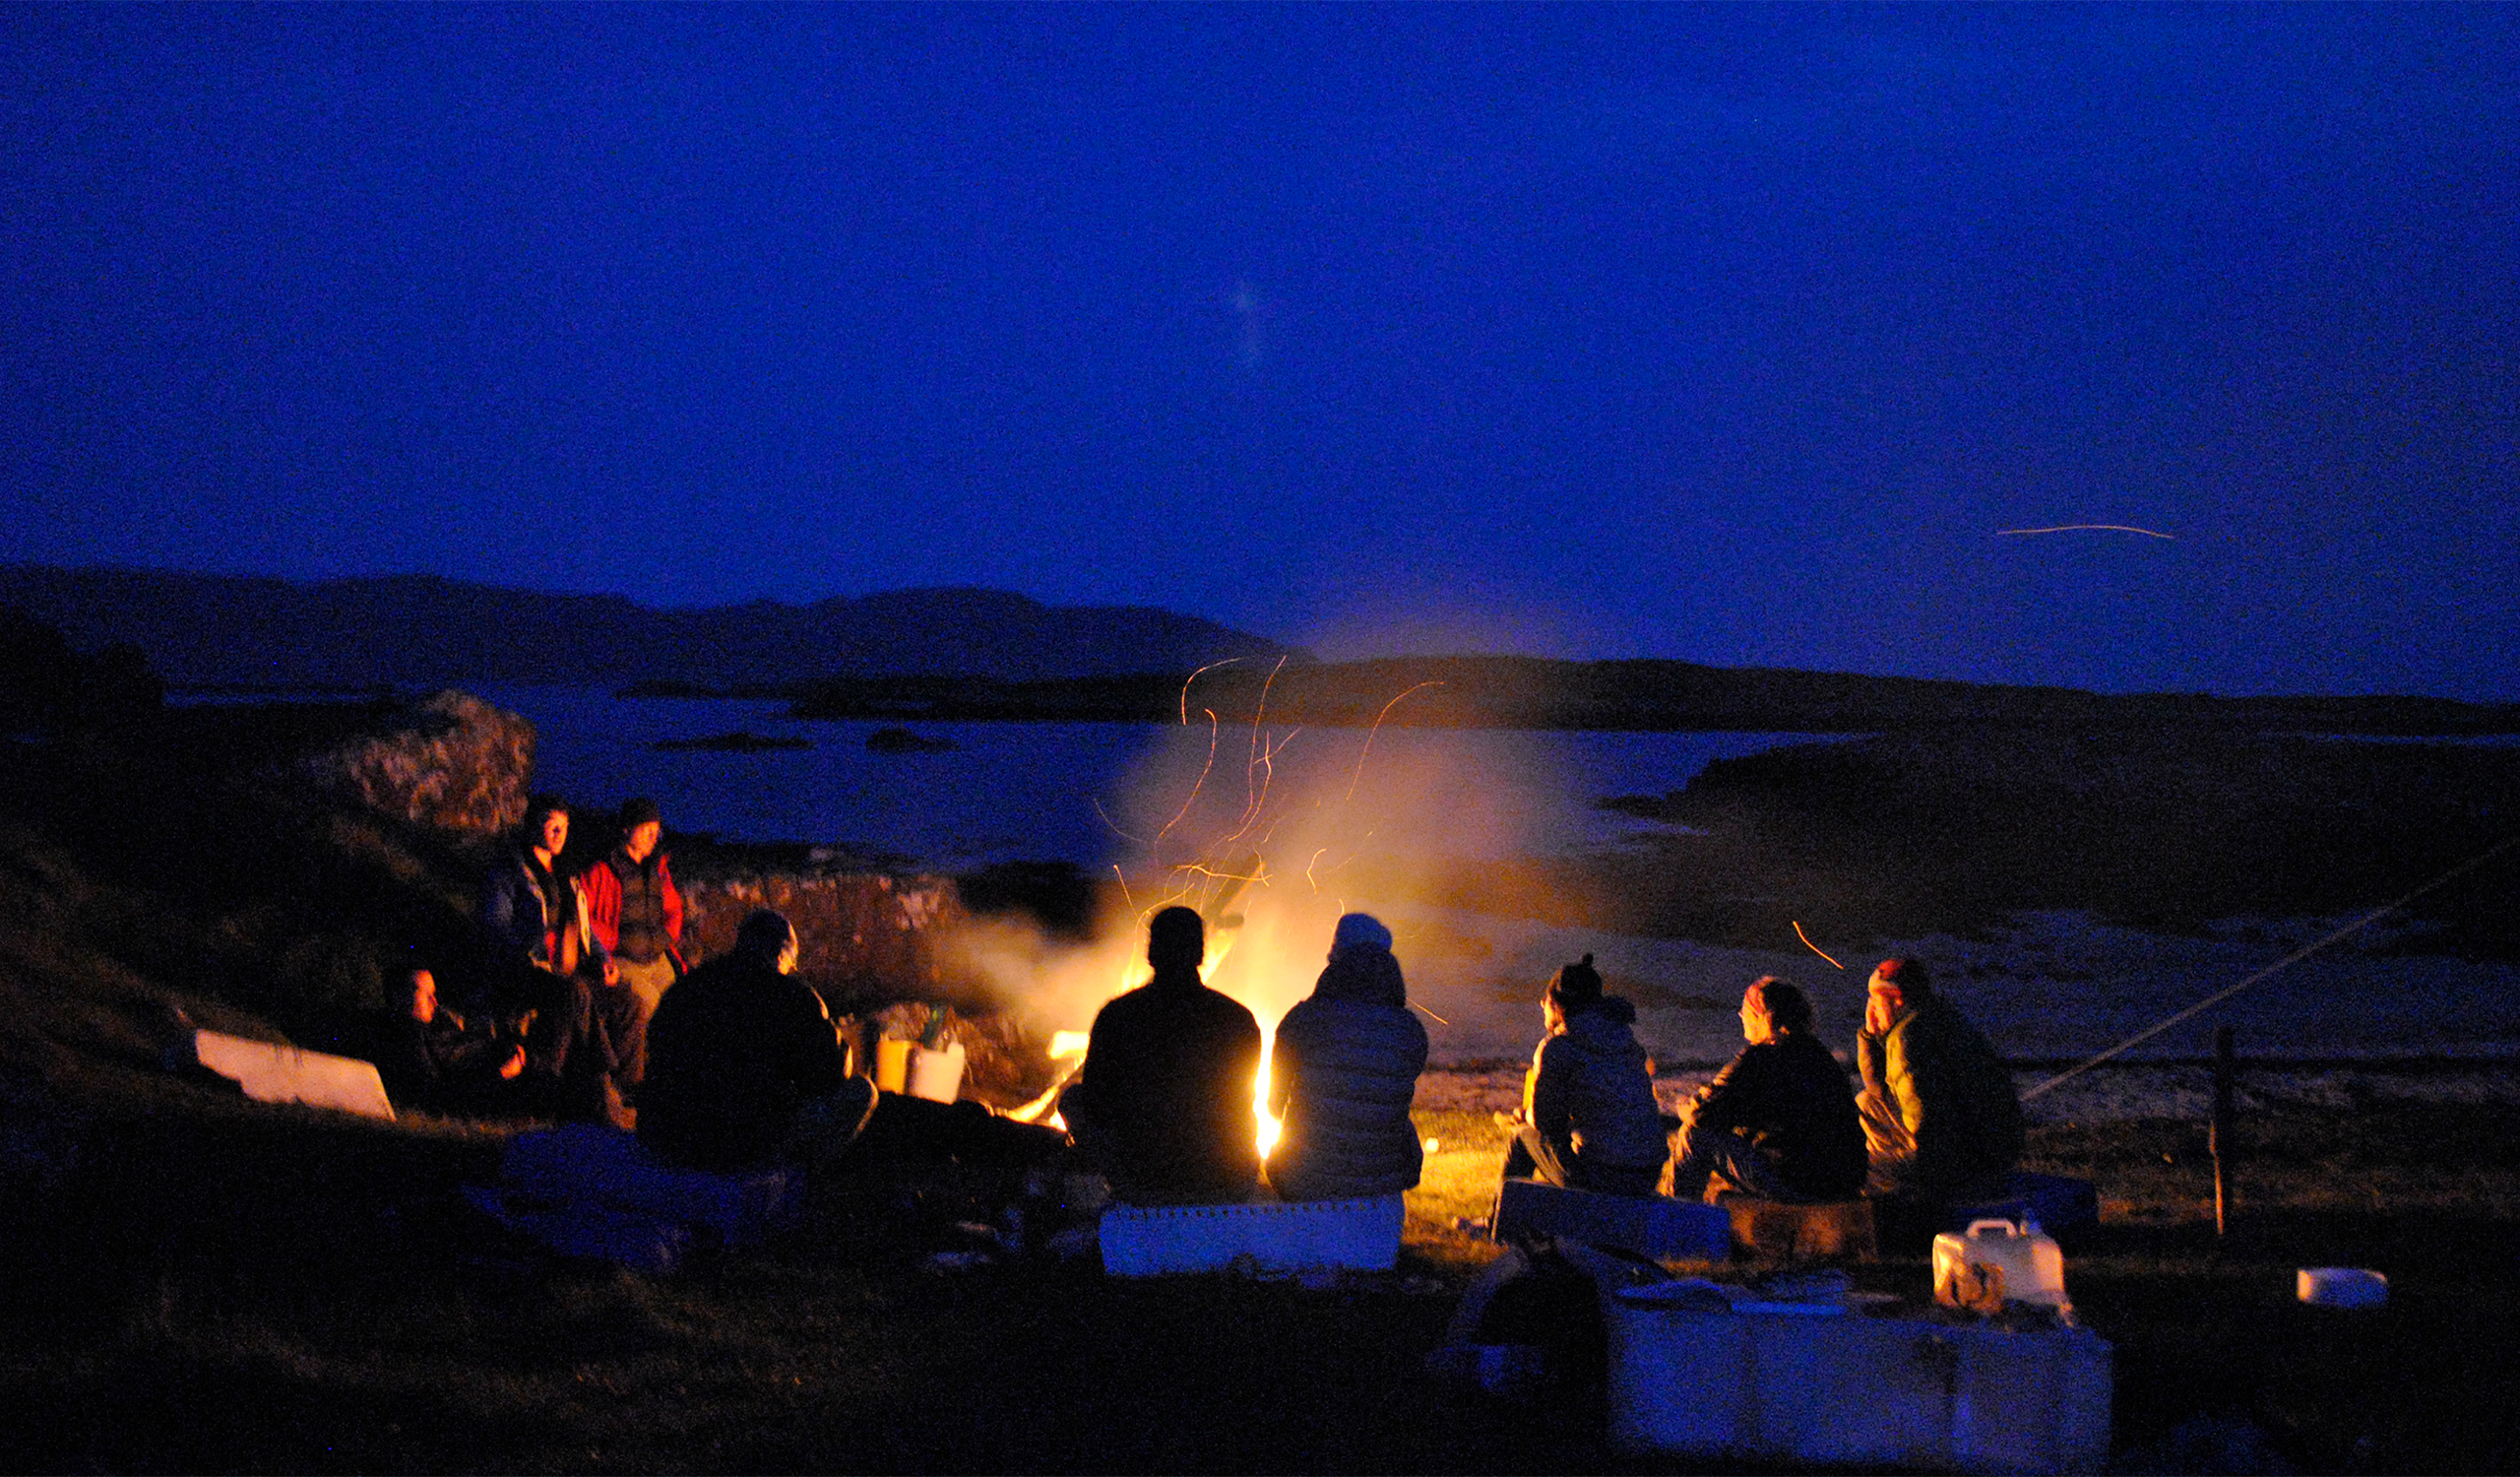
[388,781,2024,1205]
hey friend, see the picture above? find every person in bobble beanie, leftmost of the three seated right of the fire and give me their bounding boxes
[1504,955,1670,1194]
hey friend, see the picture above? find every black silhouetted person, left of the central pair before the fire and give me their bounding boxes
[1058,908,1260,1205]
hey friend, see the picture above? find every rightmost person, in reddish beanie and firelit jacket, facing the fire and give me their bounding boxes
[1855,958,2024,1202]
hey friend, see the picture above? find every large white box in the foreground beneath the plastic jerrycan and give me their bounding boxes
[1603,1296,2111,1477]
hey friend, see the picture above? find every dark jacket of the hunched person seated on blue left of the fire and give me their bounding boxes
[638,953,850,1172]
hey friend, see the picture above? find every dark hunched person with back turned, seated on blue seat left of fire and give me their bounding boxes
[638,910,877,1175]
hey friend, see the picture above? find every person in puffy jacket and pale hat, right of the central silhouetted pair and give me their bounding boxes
[1268,913,1426,1199]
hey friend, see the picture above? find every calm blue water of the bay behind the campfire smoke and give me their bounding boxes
[478,685,1812,867]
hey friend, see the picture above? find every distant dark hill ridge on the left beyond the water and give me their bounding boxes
[0,564,1310,688]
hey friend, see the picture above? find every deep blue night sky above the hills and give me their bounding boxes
[0,0,2520,698]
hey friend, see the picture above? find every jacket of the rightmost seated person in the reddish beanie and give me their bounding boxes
[1855,994,2024,1197]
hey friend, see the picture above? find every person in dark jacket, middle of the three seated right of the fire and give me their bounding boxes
[1670,976,1864,1202]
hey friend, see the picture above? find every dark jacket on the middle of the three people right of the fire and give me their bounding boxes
[1688,1031,1864,1199]
